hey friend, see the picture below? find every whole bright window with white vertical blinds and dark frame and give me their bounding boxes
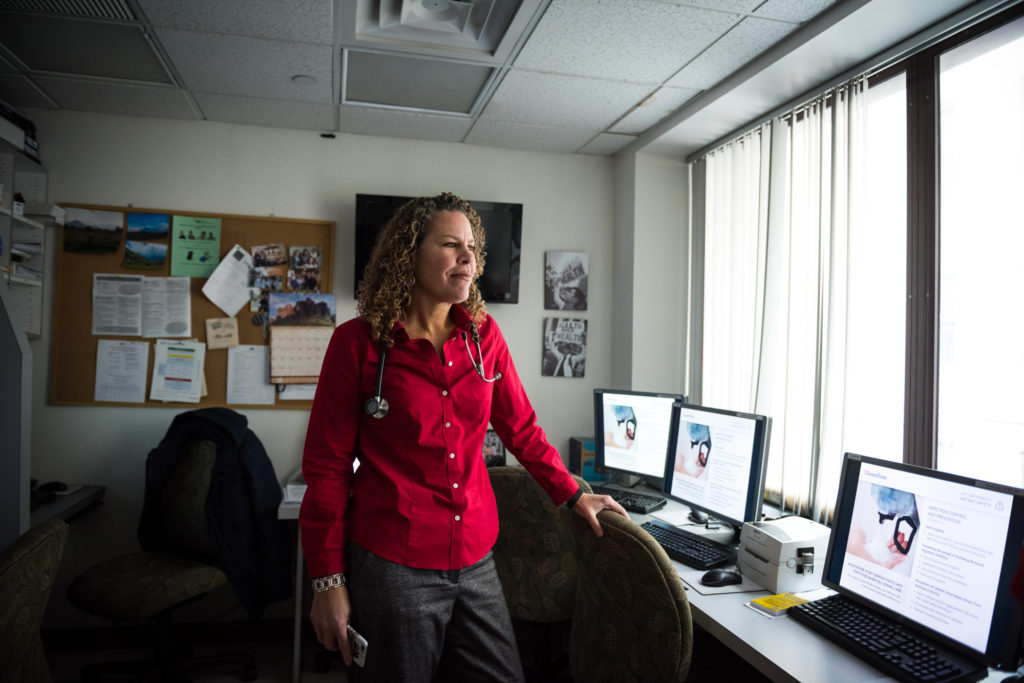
[691,5,1024,517]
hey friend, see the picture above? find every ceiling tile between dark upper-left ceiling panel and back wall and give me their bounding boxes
[35,76,199,119]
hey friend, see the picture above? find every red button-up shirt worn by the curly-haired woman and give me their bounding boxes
[299,305,578,577]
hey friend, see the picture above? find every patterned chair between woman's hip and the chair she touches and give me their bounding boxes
[487,466,591,682]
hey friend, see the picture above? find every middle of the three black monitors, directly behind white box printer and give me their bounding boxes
[663,403,771,530]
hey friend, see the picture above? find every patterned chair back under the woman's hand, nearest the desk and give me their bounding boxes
[569,510,693,683]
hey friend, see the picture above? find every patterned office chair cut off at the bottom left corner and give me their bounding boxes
[0,519,68,683]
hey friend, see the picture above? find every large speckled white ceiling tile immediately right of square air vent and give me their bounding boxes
[515,0,740,84]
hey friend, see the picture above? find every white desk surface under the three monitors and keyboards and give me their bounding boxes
[610,485,1008,683]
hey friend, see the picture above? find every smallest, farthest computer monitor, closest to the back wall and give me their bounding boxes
[594,389,683,492]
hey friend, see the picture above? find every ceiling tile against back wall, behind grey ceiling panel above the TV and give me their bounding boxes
[338,104,473,142]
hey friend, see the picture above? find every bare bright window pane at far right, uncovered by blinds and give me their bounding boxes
[936,17,1024,486]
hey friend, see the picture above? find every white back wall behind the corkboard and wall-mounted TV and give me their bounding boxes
[31,112,613,626]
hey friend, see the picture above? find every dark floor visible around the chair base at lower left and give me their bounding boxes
[47,641,345,683]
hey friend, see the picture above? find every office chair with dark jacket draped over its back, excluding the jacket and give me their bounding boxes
[68,440,256,682]
